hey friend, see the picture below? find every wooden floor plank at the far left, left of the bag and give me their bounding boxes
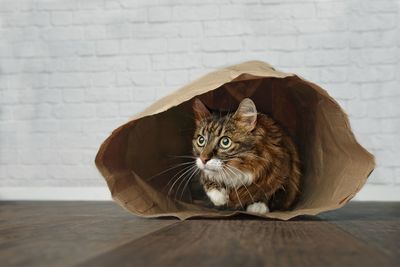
[0,202,177,266]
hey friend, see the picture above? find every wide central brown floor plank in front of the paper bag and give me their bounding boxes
[80,218,395,266]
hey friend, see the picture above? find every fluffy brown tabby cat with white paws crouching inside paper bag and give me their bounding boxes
[192,98,301,214]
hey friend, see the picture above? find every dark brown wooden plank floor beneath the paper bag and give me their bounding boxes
[0,202,400,267]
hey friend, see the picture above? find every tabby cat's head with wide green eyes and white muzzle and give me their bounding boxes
[193,98,257,186]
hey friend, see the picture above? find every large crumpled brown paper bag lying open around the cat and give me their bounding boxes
[96,61,375,220]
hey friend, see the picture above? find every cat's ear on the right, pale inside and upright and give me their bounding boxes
[233,98,257,131]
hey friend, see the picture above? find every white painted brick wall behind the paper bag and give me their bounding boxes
[0,0,400,199]
